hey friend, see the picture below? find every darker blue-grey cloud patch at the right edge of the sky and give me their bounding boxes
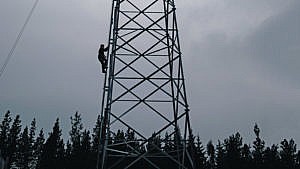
[248,1,300,89]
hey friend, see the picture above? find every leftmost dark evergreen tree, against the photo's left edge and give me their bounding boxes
[0,111,11,158]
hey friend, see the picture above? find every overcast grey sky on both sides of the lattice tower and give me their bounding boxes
[0,0,300,144]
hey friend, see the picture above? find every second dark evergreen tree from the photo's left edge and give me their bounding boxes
[7,115,21,167]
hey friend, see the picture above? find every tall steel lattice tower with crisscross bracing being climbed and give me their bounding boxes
[97,0,194,169]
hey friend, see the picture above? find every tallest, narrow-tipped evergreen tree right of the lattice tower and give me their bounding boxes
[253,124,265,169]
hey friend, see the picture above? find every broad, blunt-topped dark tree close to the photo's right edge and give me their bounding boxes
[280,139,297,169]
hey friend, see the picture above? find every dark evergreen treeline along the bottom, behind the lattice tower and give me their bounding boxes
[0,111,300,169]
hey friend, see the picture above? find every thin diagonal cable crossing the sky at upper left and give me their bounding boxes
[0,0,39,79]
